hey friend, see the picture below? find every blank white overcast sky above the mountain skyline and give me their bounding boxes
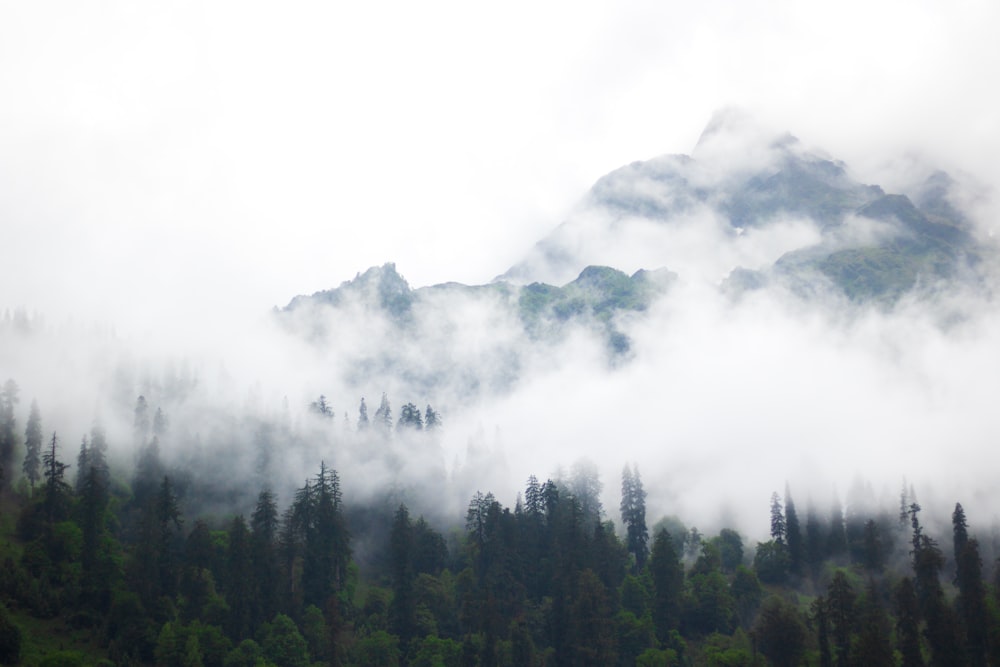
[0,0,1000,327]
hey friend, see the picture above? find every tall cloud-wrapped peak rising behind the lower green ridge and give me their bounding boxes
[498,111,994,304]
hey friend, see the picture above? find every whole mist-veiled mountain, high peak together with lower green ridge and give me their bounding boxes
[278,112,996,400]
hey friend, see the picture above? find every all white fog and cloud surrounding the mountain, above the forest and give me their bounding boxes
[0,1,1000,534]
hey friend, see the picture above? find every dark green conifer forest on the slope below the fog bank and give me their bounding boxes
[0,380,1000,667]
